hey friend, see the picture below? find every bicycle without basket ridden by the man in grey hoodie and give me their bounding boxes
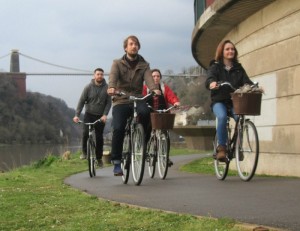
[78,119,102,177]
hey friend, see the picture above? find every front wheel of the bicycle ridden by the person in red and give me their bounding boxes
[157,132,170,180]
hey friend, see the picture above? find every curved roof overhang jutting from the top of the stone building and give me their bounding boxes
[192,0,275,69]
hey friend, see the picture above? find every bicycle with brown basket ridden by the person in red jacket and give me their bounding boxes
[146,106,175,179]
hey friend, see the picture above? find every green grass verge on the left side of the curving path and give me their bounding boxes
[0,153,251,231]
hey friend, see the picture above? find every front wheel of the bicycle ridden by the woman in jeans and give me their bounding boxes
[235,120,259,181]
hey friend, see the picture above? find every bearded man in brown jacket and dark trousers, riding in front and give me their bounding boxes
[107,35,160,176]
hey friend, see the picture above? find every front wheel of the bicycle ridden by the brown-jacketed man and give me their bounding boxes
[131,124,146,185]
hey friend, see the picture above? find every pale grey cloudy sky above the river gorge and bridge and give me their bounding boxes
[0,0,197,108]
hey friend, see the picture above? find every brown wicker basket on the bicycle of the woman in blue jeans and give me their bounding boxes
[231,93,262,115]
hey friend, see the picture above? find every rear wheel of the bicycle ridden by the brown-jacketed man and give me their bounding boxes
[121,133,131,184]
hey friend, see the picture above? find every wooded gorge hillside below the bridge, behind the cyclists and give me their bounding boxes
[0,67,214,144]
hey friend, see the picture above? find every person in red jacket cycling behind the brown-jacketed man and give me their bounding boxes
[143,69,180,167]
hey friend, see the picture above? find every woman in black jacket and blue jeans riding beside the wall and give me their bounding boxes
[205,40,253,161]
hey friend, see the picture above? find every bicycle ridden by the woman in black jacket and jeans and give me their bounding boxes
[213,82,259,181]
